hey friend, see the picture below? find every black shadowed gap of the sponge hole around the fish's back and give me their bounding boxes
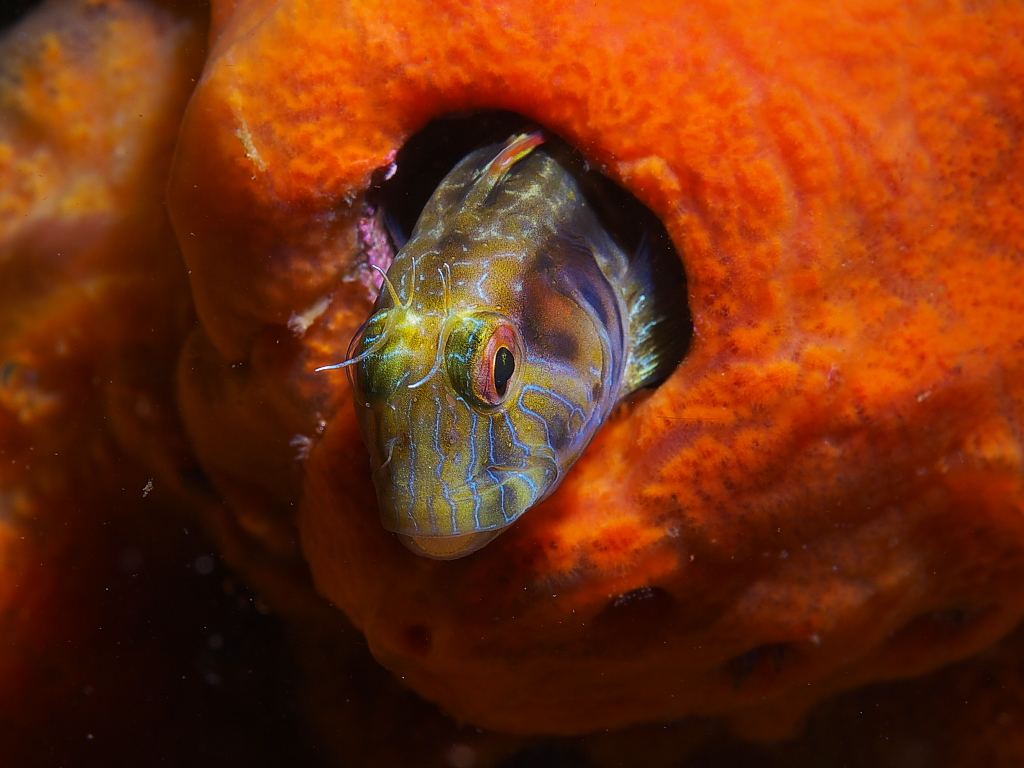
[367,111,693,385]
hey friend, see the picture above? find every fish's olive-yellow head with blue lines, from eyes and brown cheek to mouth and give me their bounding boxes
[353,236,614,559]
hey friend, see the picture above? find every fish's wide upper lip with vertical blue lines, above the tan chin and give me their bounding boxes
[374,463,560,549]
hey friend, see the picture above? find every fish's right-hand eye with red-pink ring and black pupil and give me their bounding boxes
[444,312,522,409]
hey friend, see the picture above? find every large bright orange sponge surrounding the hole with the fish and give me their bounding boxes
[163,0,1024,734]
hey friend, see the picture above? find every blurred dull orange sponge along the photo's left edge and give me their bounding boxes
[0,0,203,765]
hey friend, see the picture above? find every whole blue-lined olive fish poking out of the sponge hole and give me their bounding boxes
[331,132,683,559]
